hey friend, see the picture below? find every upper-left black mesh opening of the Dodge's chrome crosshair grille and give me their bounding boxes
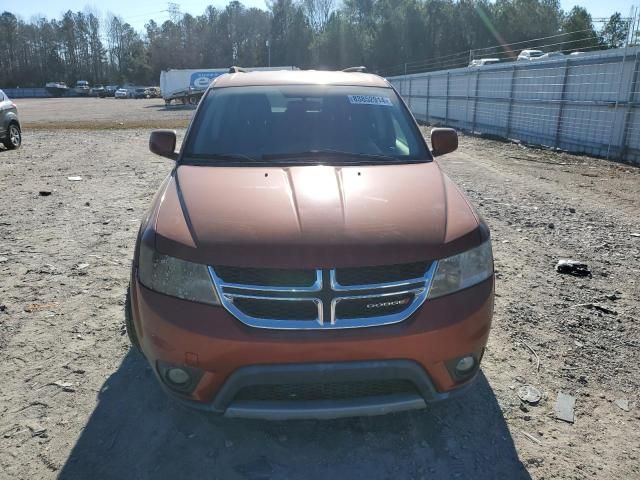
[216,266,316,287]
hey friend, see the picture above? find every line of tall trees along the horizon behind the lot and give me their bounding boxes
[0,0,629,88]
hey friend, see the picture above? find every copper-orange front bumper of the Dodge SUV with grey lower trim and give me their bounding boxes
[131,275,493,419]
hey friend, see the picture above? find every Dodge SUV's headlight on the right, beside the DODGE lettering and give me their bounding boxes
[429,240,493,298]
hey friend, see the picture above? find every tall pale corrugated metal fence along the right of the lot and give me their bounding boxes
[388,47,640,163]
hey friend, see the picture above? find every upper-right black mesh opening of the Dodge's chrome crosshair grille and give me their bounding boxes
[336,262,431,287]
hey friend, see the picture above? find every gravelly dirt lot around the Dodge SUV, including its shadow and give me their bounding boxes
[0,99,640,480]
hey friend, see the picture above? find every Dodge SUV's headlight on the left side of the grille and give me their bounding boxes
[138,242,220,305]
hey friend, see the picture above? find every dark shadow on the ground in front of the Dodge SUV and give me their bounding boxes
[59,351,531,480]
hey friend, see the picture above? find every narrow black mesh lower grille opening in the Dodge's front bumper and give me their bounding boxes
[234,379,418,401]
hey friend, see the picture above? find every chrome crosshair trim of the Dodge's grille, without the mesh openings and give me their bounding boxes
[209,261,438,330]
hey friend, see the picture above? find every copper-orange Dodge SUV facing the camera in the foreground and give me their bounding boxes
[125,69,494,419]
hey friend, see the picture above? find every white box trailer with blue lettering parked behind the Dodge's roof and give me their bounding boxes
[160,67,296,105]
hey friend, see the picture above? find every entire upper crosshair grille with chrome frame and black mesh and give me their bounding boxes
[209,261,437,329]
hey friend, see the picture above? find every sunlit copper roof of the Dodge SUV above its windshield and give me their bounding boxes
[211,70,390,88]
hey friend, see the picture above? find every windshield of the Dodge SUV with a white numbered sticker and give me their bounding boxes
[185,85,431,163]
